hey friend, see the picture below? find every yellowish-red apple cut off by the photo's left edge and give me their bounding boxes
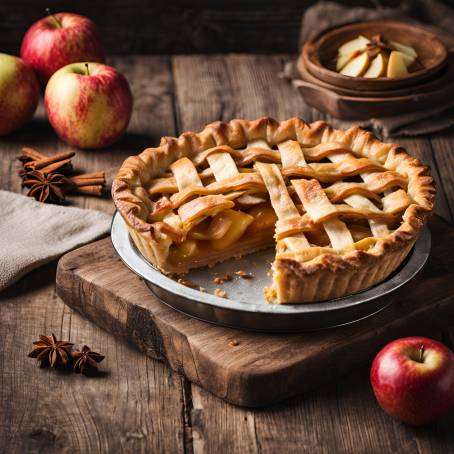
[0,53,40,135]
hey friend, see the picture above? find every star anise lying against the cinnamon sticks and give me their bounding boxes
[22,170,68,203]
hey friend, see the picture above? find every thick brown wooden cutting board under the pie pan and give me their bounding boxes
[57,217,454,406]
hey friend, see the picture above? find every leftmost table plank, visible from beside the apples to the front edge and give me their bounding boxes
[0,57,188,453]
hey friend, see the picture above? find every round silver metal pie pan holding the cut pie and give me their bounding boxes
[111,212,431,333]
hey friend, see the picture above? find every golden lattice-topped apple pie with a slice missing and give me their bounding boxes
[112,118,435,303]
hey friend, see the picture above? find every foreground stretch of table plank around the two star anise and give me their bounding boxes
[0,265,184,453]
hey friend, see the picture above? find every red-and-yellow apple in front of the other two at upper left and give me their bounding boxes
[44,63,133,148]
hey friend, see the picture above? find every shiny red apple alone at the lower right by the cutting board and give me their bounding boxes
[370,337,454,426]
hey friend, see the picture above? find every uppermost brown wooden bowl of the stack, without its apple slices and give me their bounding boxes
[302,20,447,91]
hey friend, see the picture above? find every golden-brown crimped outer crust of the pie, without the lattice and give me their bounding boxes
[112,117,435,302]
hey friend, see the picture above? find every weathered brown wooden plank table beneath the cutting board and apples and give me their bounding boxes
[0,55,454,453]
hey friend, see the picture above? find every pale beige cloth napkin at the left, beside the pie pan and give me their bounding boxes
[0,191,111,291]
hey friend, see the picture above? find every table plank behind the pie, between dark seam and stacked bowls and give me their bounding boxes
[172,55,313,131]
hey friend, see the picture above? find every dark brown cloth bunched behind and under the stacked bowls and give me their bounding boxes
[290,0,454,137]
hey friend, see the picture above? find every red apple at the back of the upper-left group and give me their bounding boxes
[20,13,104,87]
